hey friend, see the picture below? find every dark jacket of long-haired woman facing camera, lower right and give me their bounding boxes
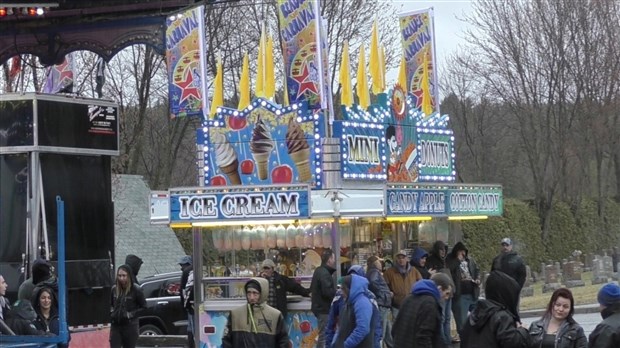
[528,317,588,348]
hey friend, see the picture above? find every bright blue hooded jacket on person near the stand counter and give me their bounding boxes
[332,274,374,348]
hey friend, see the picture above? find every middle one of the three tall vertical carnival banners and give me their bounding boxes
[278,0,329,109]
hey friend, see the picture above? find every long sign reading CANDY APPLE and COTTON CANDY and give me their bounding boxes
[385,184,504,216]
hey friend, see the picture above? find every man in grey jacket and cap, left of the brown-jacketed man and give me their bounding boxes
[366,255,394,348]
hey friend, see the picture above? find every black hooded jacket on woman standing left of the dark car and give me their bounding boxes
[110,265,146,325]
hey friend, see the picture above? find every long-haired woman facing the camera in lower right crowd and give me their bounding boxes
[529,288,588,348]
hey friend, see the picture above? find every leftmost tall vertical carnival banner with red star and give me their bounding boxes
[166,6,209,118]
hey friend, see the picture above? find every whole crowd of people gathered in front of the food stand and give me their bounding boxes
[0,242,620,348]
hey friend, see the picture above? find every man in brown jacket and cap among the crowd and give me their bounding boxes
[383,250,422,318]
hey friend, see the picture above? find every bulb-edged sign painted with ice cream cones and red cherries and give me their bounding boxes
[197,98,324,188]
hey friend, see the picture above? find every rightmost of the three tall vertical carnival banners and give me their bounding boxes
[399,8,439,117]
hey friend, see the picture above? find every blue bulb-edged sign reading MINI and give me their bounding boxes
[333,121,387,181]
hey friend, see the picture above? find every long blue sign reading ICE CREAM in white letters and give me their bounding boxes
[170,188,310,222]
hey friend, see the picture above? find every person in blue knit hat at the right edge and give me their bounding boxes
[588,283,620,348]
